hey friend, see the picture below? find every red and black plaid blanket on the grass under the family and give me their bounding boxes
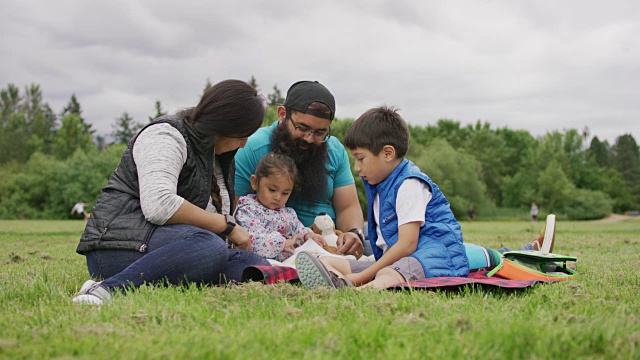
[242,266,553,290]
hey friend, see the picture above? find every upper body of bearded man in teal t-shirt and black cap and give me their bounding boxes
[235,81,364,257]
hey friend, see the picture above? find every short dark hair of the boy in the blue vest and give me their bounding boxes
[344,106,409,158]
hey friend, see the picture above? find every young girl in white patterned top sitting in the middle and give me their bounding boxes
[235,153,326,261]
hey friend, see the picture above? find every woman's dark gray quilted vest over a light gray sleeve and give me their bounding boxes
[76,115,235,254]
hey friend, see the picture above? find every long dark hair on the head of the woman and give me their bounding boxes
[182,80,265,138]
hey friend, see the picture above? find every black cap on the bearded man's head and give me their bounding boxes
[284,80,336,120]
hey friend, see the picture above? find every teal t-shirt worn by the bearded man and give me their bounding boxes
[235,122,354,226]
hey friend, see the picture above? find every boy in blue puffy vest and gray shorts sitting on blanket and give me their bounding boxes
[296,106,469,289]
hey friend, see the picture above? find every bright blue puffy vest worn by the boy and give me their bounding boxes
[364,159,469,278]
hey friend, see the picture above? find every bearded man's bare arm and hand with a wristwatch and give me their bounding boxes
[331,184,364,257]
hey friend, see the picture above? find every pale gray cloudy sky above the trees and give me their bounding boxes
[0,0,640,142]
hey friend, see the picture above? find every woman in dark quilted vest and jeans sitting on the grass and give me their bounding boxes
[73,80,269,304]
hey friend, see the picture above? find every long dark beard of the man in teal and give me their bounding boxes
[271,120,328,202]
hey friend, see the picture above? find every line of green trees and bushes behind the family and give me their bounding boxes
[0,76,640,219]
